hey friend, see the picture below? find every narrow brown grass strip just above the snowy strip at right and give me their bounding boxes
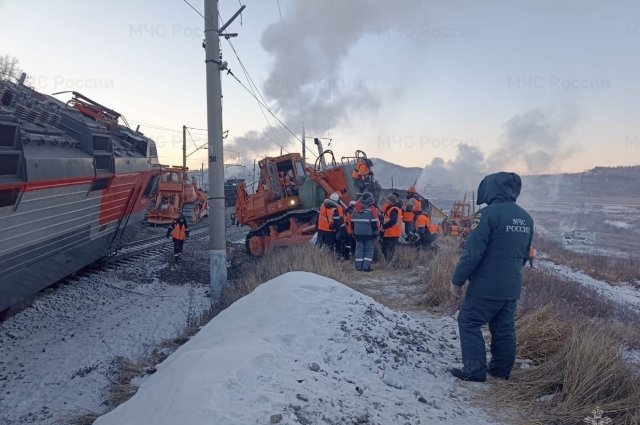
[535,236,640,282]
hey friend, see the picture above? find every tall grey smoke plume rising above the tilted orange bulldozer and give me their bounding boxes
[229,0,427,157]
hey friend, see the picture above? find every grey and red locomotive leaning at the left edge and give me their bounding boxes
[0,76,159,311]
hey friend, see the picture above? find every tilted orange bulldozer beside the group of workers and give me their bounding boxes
[235,139,379,256]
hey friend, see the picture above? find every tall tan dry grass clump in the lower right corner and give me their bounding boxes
[495,316,640,425]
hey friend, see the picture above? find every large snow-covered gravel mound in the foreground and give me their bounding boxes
[95,272,500,425]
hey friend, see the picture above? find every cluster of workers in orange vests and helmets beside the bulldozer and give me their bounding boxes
[317,186,438,271]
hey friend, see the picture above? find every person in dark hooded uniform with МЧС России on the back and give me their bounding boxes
[451,172,533,382]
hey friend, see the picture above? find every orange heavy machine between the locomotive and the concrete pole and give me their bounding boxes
[147,167,209,225]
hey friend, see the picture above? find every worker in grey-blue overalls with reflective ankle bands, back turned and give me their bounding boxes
[351,192,380,272]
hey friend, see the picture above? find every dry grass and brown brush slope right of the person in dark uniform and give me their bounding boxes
[495,269,640,425]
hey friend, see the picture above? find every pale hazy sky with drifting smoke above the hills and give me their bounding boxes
[0,0,640,173]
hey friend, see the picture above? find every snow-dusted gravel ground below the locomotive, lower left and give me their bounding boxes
[0,257,210,425]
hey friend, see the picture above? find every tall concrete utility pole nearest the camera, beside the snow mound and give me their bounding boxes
[204,0,227,302]
